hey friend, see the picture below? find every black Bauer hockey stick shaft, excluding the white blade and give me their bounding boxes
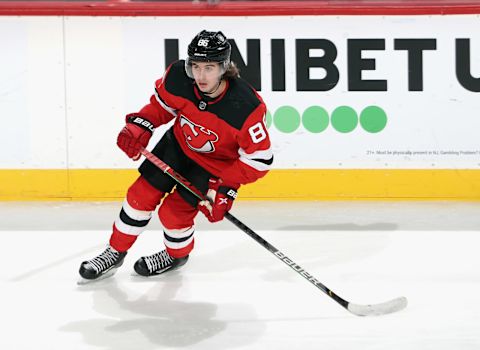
[141,149,349,310]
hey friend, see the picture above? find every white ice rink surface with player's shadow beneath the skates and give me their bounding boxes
[0,203,480,350]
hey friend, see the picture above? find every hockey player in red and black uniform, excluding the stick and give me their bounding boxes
[79,30,273,280]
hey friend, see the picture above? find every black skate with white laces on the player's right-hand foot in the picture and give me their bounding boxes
[133,250,188,277]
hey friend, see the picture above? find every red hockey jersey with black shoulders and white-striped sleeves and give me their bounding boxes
[135,60,273,186]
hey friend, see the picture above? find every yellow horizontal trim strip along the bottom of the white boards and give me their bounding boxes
[0,169,480,201]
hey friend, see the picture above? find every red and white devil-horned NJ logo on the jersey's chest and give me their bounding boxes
[180,115,218,153]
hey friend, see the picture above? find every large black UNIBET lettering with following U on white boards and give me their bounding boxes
[165,38,480,92]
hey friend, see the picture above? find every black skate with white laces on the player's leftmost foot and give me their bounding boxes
[78,246,127,284]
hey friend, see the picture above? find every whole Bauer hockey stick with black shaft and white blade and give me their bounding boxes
[141,149,407,316]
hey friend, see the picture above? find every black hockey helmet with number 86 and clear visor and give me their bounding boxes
[185,30,232,79]
